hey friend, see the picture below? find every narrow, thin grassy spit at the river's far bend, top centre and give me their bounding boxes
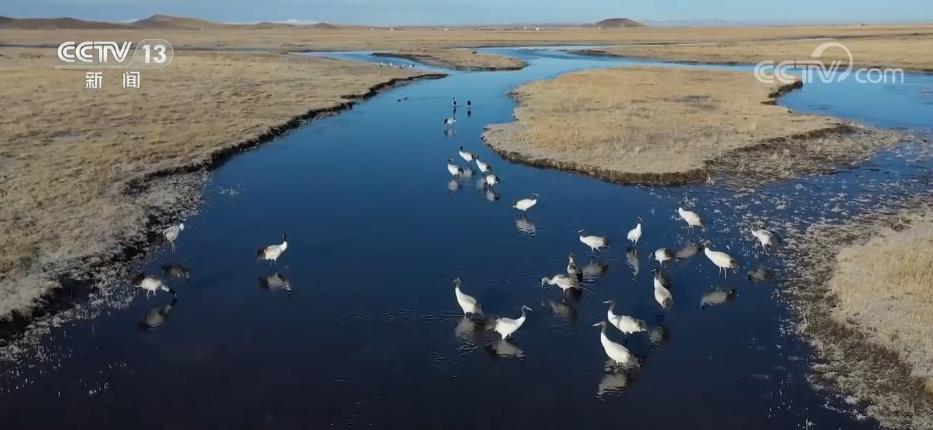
[373,49,525,71]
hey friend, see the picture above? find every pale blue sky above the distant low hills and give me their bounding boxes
[0,0,933,25]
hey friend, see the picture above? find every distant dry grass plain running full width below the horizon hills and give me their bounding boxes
[0,25,933,50]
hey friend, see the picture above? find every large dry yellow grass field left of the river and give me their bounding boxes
[0,48,430,315]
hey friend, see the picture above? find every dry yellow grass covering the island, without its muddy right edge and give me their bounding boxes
[485,68,876,182]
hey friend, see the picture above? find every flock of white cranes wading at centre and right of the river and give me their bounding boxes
[443,106,777,369]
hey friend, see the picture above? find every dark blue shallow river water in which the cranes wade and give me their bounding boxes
[0,49,933,429]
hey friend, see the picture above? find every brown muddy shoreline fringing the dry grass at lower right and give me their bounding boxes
[781,193,933,429]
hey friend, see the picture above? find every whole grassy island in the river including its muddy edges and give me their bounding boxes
[484,68,899,185]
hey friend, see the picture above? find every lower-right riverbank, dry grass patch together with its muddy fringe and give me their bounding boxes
[785,200,933,429]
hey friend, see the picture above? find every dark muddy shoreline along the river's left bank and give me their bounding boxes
[0,73,446,348]
